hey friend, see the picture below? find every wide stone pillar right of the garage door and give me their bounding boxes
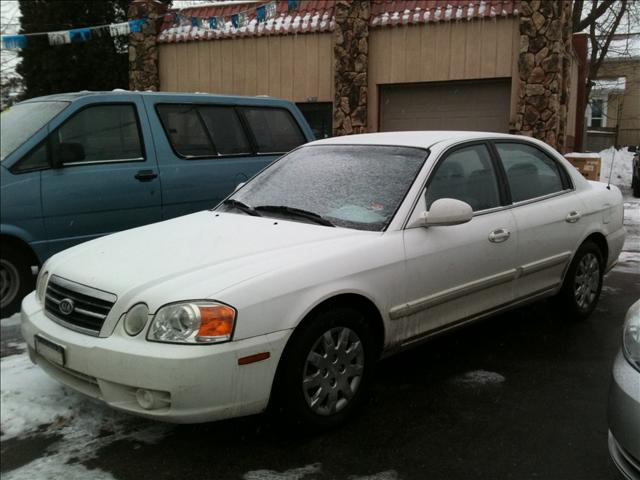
[514,0,571,151]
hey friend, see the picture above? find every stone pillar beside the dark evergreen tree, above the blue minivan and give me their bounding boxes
[128,0,167,92]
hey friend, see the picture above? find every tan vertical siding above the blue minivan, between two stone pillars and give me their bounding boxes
[159,33,333,102]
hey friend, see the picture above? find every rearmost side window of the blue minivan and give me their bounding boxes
[243,108,305,153]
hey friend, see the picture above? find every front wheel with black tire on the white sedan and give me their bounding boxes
[272,306,379,432]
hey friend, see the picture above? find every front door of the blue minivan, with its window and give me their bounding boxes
[42,101,161,254]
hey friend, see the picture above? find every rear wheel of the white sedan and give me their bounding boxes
[558,240,604,320]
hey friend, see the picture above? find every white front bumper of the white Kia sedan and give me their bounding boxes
[21,293,291,423]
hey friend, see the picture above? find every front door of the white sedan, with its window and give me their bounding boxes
[392,144,517,337]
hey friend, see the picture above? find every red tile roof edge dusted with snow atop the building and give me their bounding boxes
[158,0,520,43]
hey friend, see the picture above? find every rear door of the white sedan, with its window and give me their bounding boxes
[494,141,585,298]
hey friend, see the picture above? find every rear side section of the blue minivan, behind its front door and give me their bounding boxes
[145,96,306,218]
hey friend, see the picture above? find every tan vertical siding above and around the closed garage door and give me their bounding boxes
[368,18,519,131]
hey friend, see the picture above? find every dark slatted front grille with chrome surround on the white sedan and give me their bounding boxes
[44,275,117,335]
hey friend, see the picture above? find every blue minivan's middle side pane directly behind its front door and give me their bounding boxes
[157,104,217,158]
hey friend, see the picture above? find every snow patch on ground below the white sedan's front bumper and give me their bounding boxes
[0,353,172,480]
